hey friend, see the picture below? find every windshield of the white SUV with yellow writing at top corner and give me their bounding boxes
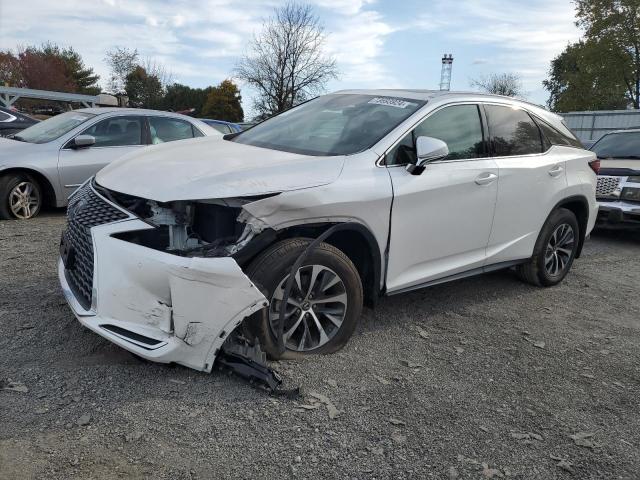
[233,94,425,156]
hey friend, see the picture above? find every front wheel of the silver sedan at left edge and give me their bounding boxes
[0,174,42,220]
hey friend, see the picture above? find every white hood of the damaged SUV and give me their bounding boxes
[96,138,345,202]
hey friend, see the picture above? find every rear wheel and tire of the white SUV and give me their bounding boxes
[516,208,580,287]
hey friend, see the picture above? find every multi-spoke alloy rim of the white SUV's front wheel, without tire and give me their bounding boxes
[269,265,347,352]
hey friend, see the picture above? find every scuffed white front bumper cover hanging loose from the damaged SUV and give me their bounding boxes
[58,218,267,371]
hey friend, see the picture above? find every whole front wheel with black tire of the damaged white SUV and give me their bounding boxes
[247,238,363,359]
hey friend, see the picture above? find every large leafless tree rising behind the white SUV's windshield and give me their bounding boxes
[235,3,337,118]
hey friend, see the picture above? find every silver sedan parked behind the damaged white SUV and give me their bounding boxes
[0,108,222,219]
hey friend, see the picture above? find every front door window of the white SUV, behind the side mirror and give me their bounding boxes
[387,105,485,165]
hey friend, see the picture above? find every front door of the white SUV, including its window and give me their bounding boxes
[386,104,498,293]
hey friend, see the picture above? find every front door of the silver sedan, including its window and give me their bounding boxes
[58,115,147,197]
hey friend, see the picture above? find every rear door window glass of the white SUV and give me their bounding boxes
[484,105,543,157]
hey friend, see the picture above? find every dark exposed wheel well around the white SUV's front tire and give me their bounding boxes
[278,224,382,306]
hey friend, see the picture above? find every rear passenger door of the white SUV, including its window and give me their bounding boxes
[484,104,567,264]
